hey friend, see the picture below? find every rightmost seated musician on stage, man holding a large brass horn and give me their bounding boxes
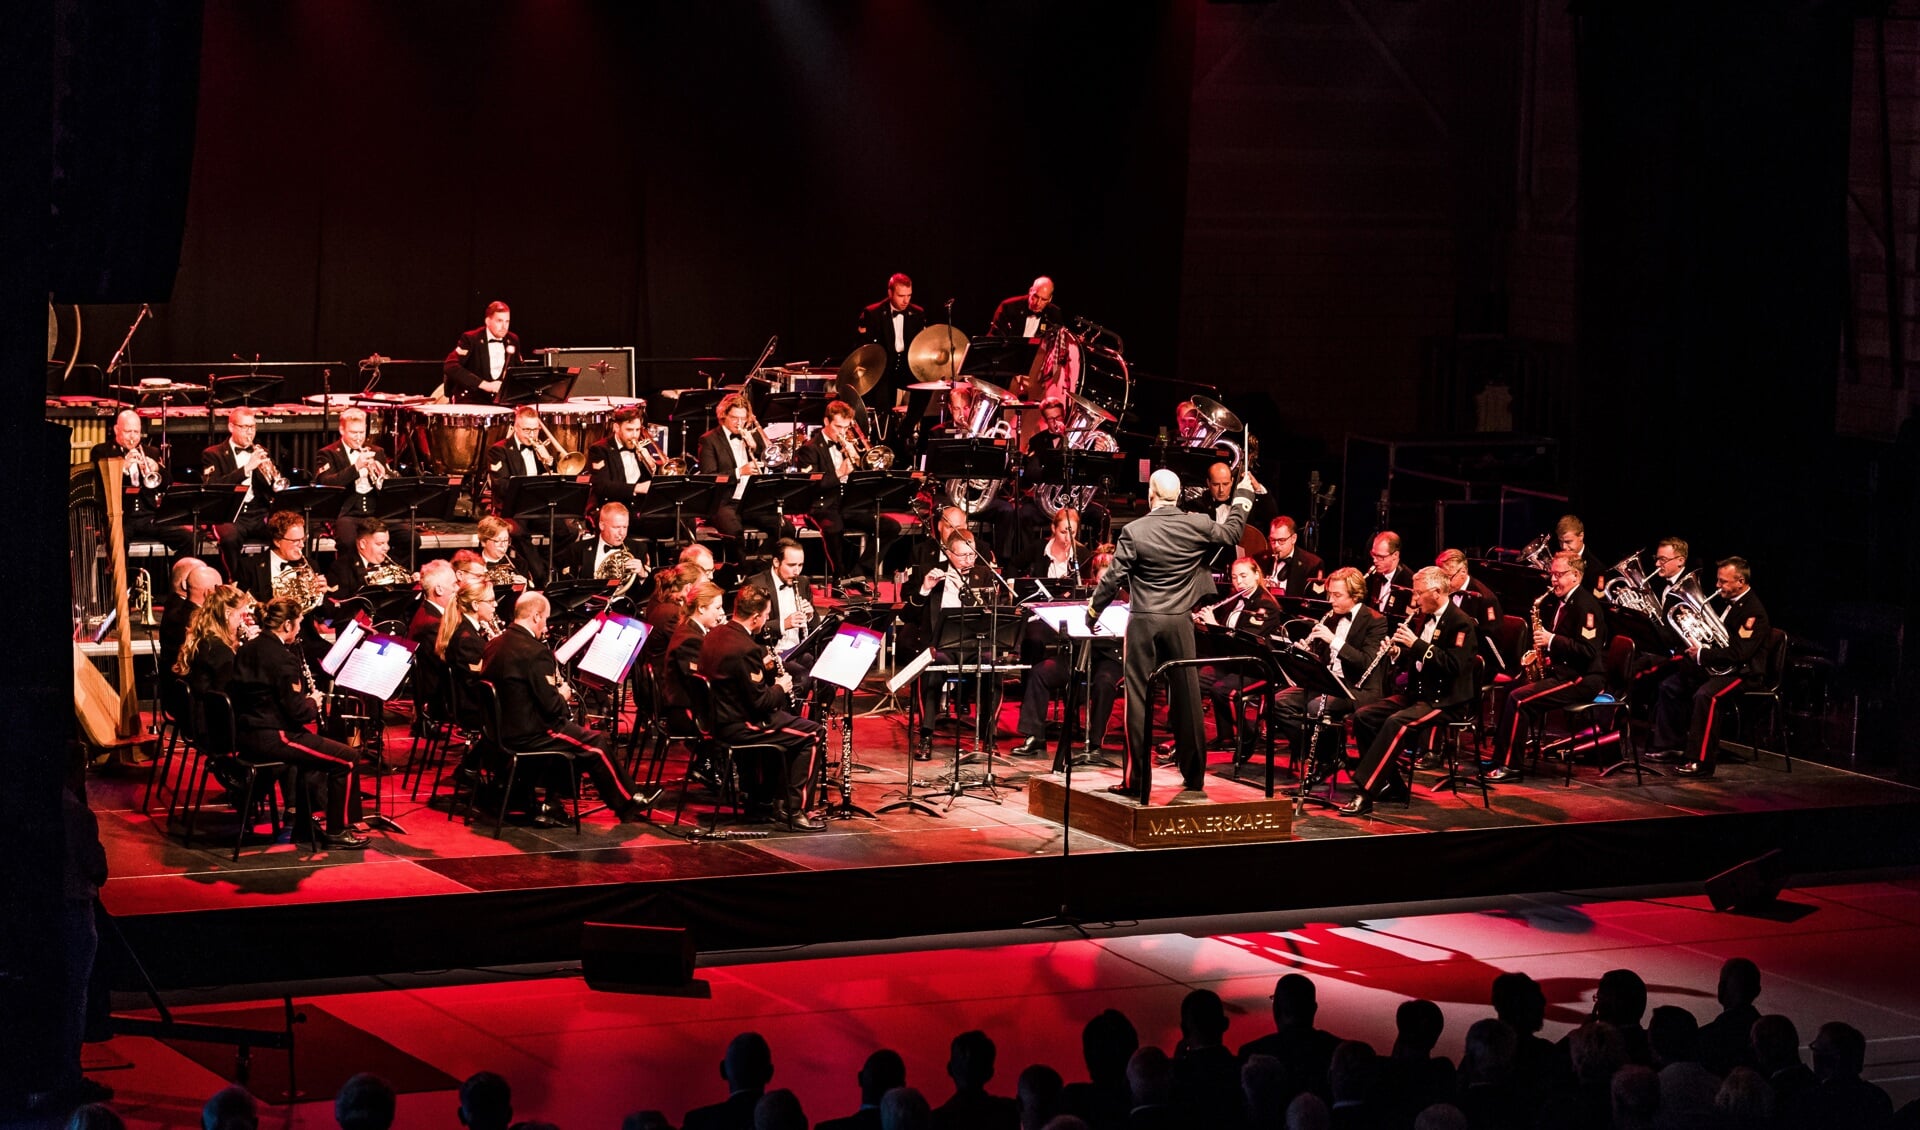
[1653,556,1772,777]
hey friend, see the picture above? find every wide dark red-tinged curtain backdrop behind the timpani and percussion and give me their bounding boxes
[83,0,1194,395]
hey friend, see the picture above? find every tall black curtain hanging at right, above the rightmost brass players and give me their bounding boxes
[1567,4,1853,625]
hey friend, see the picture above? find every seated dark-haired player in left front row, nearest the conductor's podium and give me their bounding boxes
[699,585,826,833]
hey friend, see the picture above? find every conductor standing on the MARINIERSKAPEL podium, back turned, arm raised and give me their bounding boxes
[1087,468,1263,804]
